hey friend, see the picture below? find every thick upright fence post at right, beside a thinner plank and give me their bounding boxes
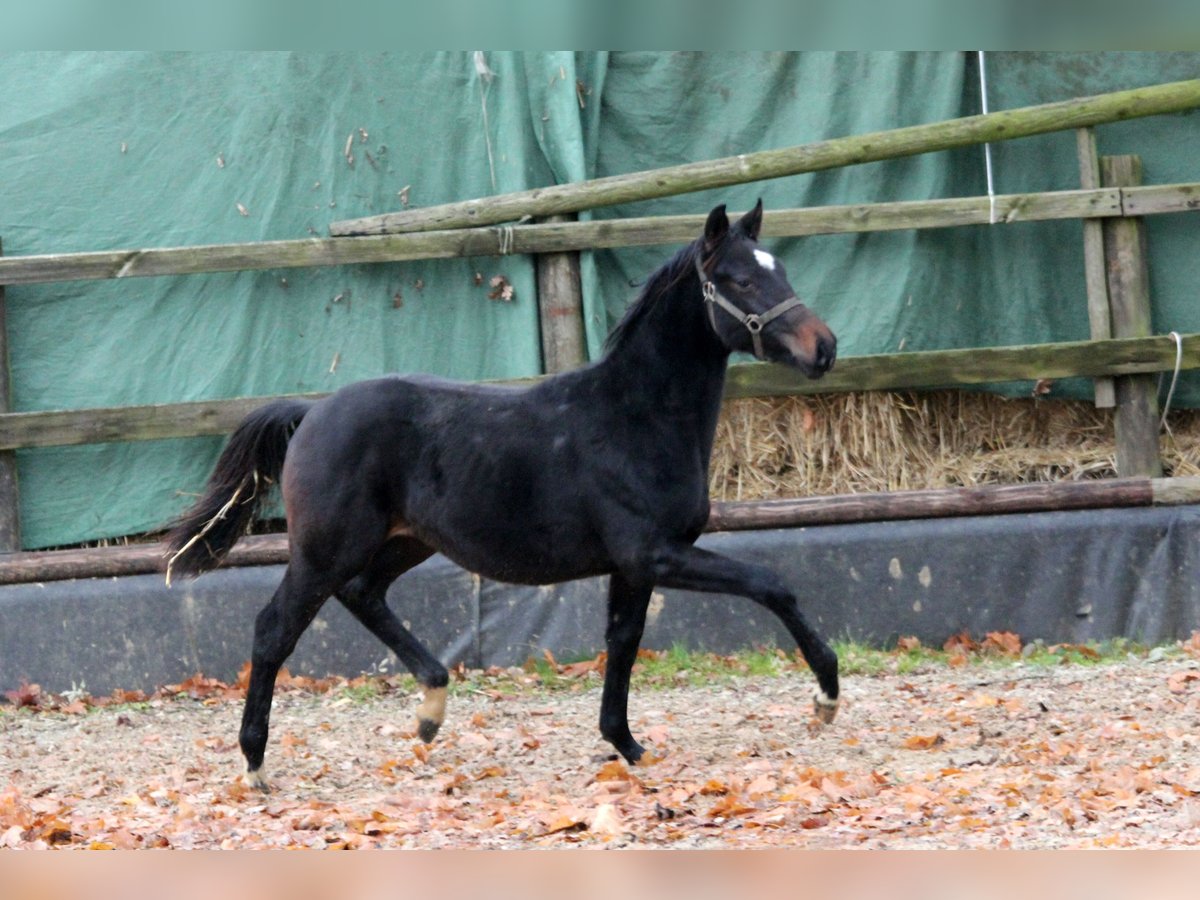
[1100,156,1163,478]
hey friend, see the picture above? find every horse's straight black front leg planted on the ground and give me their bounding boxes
[600,572,652,766]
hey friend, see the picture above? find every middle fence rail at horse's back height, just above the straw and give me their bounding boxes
[0,335,1200,450]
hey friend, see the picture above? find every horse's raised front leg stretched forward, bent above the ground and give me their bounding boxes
[653,544,838,722]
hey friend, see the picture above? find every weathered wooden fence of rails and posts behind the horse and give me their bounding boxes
[0,80,1200,583]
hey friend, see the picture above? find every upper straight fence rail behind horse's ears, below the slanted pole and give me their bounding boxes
[0,184,1200,284]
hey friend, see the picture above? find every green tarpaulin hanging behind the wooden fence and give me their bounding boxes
[0,52,1200,547]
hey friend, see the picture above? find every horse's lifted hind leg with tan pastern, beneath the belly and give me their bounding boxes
[336,538,450,744]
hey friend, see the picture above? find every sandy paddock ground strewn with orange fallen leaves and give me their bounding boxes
[7,654,1200,848]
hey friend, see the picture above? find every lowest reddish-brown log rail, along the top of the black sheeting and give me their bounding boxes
[9,478,1200,584]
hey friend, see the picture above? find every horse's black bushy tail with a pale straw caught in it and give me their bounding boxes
[163,400,312,586]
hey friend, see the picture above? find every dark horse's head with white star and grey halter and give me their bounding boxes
[696,200,838,378]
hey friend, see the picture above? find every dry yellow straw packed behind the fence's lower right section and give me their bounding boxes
[710,391,1200,500]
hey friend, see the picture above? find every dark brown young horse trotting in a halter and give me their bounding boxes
[167,202,838,790]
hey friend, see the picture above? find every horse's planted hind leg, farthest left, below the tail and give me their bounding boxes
[238,558,332,791]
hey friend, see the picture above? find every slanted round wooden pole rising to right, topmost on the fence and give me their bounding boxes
[329,80,1200,236]
